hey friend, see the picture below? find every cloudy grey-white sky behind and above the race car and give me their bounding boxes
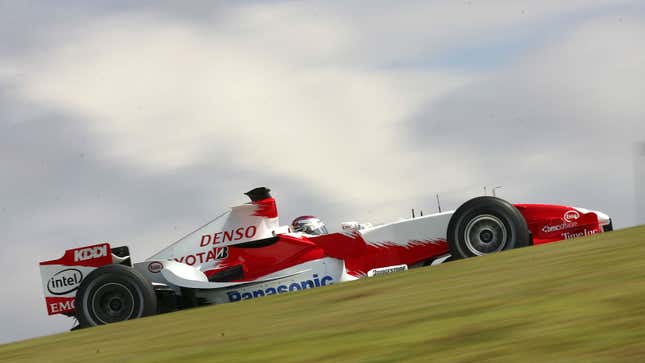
[0,0,645,343]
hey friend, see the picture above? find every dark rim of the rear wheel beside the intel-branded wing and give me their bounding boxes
[91,282,135,324]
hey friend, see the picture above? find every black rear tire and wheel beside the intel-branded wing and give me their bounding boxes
[75,265,157,328]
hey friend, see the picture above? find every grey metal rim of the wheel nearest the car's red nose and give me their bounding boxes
[464,214,509,256]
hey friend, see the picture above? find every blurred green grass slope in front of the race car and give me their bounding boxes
[0,227,645,363]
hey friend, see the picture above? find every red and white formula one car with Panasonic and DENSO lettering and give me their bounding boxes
[40,188,612,327]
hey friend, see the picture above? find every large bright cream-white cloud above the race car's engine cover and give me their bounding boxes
[10,14,467,219]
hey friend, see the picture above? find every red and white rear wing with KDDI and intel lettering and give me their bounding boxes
[39,243,129,315]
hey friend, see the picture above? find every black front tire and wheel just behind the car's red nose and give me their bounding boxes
[448,196,531,259]
